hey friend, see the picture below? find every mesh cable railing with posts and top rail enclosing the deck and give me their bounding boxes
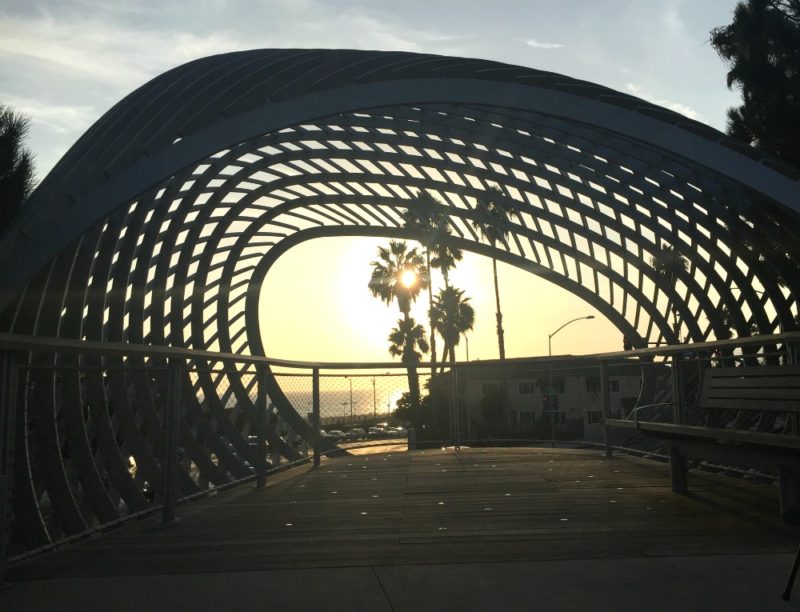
[0,332,800,572]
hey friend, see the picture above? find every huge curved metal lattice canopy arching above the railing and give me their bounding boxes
[0,50,800,548]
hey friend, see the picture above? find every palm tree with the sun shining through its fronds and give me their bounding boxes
[368,240,428,418]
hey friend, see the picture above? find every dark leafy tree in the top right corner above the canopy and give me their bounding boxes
[711,0,800,167]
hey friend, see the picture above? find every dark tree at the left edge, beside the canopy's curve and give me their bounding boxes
[0,105,34,234]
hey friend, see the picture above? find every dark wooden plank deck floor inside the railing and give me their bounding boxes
[9,448,800,581]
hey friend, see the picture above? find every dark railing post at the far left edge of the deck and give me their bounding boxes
[0,351,17,589]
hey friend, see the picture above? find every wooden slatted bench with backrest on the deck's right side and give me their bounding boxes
[606,366,800,522]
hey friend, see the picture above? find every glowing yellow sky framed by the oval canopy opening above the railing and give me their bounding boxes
[261,238,622,362]
